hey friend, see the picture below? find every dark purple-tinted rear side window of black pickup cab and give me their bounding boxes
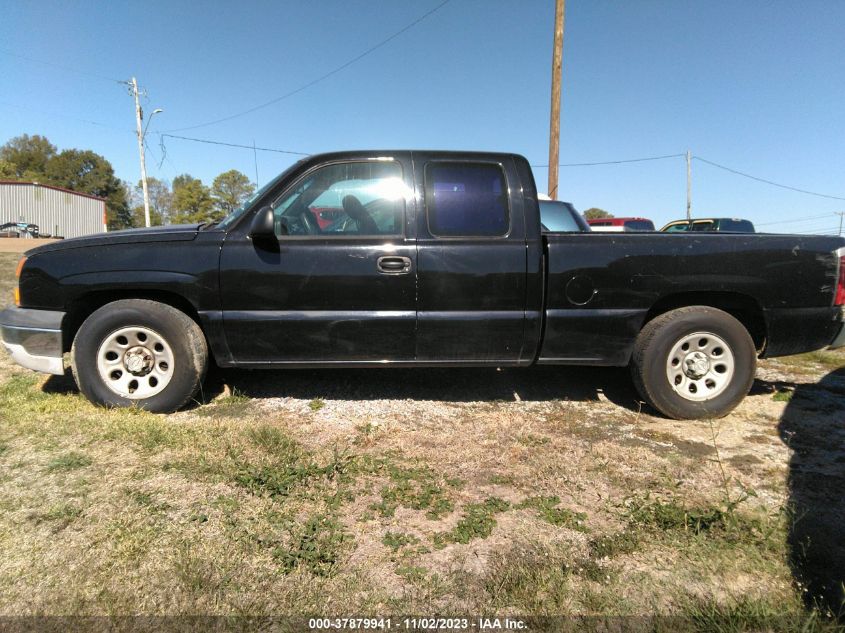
[425,162,510,237]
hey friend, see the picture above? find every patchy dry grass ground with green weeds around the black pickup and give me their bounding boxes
[0,238,845,616]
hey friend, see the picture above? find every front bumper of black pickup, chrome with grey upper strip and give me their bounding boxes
[0,308,65,376]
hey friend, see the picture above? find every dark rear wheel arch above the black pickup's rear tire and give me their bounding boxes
[642,291,767,354]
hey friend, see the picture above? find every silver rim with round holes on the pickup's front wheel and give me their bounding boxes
[97,325,175,400]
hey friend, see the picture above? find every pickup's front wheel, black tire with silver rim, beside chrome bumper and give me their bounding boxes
[71,299,208,413]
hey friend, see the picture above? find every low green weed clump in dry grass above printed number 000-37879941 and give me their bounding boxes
[273,514,351,576]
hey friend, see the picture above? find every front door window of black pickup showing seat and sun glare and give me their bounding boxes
[273,161,409,237]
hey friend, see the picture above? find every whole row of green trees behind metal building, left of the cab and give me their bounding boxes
[0,134,255,230]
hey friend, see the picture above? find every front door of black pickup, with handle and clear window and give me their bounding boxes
[220,153,416,365]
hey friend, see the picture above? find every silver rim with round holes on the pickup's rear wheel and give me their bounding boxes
[666,332,736,402]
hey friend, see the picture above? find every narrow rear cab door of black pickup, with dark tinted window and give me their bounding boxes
[414,152,528,365]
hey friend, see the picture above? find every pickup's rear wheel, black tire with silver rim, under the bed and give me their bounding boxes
[631,306,757,420]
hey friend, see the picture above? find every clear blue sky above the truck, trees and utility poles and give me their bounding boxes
[0,0,845,232]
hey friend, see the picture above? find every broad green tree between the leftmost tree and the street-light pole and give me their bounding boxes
[45,149,132,230]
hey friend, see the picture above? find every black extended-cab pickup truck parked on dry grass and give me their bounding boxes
[0,151,845,418]
